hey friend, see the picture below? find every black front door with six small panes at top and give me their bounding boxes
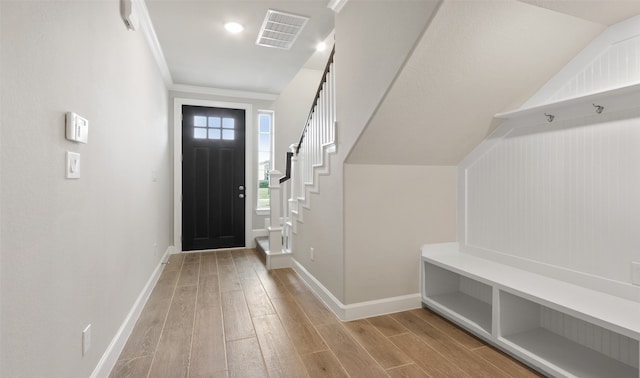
[182,105,245,251]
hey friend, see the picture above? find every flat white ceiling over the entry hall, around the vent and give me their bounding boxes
[146,0,334,94]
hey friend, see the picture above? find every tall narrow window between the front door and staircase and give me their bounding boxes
[256,110,274,210]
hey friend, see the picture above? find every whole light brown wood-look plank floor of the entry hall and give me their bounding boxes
[110,249,538,378]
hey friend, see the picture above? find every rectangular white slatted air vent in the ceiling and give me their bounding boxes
[256,9,309,50]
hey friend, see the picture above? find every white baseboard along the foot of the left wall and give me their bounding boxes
[91,246,175,378]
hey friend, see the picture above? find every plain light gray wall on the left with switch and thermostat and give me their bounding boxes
[0,1,173,377]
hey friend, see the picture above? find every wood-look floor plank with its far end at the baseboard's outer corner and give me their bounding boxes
[317,323,388,377]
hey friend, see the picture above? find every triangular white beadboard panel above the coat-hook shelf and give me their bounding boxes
[548,35,640,102]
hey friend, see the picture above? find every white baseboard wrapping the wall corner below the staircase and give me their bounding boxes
[292,259,422,321]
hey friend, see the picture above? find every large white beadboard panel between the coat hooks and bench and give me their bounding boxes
[466,118,640,283]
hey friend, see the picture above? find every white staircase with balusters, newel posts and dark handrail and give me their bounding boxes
[256,48,336,269]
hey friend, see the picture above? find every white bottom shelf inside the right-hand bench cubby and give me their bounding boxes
[503,328,638,378]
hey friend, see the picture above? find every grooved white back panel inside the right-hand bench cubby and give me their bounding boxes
[540,306,639,368]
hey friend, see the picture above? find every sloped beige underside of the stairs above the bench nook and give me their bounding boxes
[346,0,640,165]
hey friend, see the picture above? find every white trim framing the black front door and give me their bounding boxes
[173,97,255,252]
